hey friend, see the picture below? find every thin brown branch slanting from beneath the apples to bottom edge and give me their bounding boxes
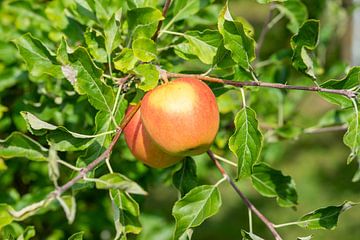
[207,150,282,240]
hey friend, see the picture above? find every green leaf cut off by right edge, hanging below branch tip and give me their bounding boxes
[343,114,360,164]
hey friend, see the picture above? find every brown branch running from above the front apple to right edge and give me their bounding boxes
[166,72,357,98]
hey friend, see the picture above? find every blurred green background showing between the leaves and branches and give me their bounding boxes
[0,0,360,240]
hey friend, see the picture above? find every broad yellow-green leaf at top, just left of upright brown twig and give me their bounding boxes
[128,7,164,39]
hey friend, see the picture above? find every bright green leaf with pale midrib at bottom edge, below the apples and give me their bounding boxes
[172,185,221,239]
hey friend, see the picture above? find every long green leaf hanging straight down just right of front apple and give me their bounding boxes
[229,107,262,178]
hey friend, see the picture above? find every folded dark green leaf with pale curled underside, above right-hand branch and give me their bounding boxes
[291,19,320,79]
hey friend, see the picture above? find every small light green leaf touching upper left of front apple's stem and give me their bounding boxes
[135,64,159,92]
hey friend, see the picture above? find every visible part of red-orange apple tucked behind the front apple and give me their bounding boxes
[124,106,182,168]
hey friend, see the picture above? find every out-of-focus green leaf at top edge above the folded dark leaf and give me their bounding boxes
[275,0,308,33]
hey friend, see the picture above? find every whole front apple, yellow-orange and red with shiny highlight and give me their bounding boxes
[140,78,219,156]
